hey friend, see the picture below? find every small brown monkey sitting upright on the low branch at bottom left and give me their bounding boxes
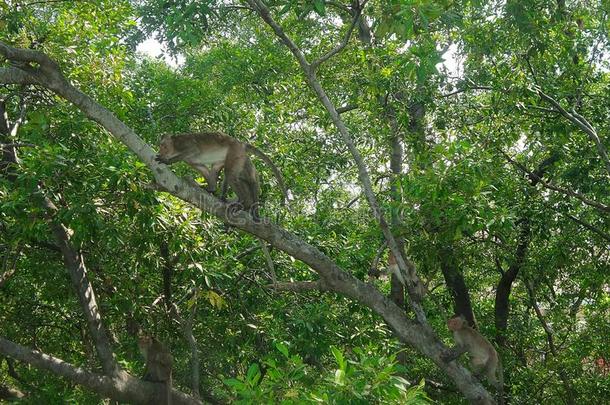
[138,335,174,405]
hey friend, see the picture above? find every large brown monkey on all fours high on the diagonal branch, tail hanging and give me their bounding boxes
[155,132,287,220]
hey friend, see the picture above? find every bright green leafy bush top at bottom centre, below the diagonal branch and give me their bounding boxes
[225,343,430,404]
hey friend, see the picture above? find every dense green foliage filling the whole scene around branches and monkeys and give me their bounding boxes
[0,0,610,404]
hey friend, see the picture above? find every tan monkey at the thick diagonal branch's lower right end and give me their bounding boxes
[443,315,504,405]
